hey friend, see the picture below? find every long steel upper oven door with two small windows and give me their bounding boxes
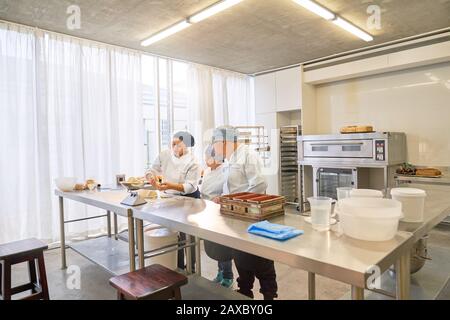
[303,139,374,159]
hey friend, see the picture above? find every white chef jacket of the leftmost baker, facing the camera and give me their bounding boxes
[149,150,200,195]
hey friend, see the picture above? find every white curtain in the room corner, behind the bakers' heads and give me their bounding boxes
[188,63,255,160]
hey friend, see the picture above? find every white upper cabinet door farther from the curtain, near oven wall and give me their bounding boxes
[275,67,302,111]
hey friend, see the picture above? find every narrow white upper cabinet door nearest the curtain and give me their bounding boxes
[255,73,277,114]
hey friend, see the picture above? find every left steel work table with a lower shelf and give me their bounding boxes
[55,187,136,274]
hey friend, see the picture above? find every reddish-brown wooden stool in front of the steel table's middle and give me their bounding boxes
[109,264,188,300]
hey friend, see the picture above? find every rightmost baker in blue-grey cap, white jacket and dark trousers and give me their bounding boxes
[212,126,278,300]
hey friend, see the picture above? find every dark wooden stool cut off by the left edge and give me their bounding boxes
[0,239,49,300]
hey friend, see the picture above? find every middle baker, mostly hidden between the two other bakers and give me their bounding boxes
[200,145,234,288]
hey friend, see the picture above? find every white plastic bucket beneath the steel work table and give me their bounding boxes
[144,224,178,270]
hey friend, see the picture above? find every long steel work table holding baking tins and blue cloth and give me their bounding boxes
[133,197,414,299]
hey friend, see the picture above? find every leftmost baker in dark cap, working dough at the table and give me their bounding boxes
[145,131,200,269]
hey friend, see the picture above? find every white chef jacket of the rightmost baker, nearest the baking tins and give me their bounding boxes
[222,144,267,195]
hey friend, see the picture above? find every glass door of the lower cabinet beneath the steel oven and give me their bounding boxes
[317,168,355,199]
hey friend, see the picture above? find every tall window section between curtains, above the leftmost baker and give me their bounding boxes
[142,55,188,168]
